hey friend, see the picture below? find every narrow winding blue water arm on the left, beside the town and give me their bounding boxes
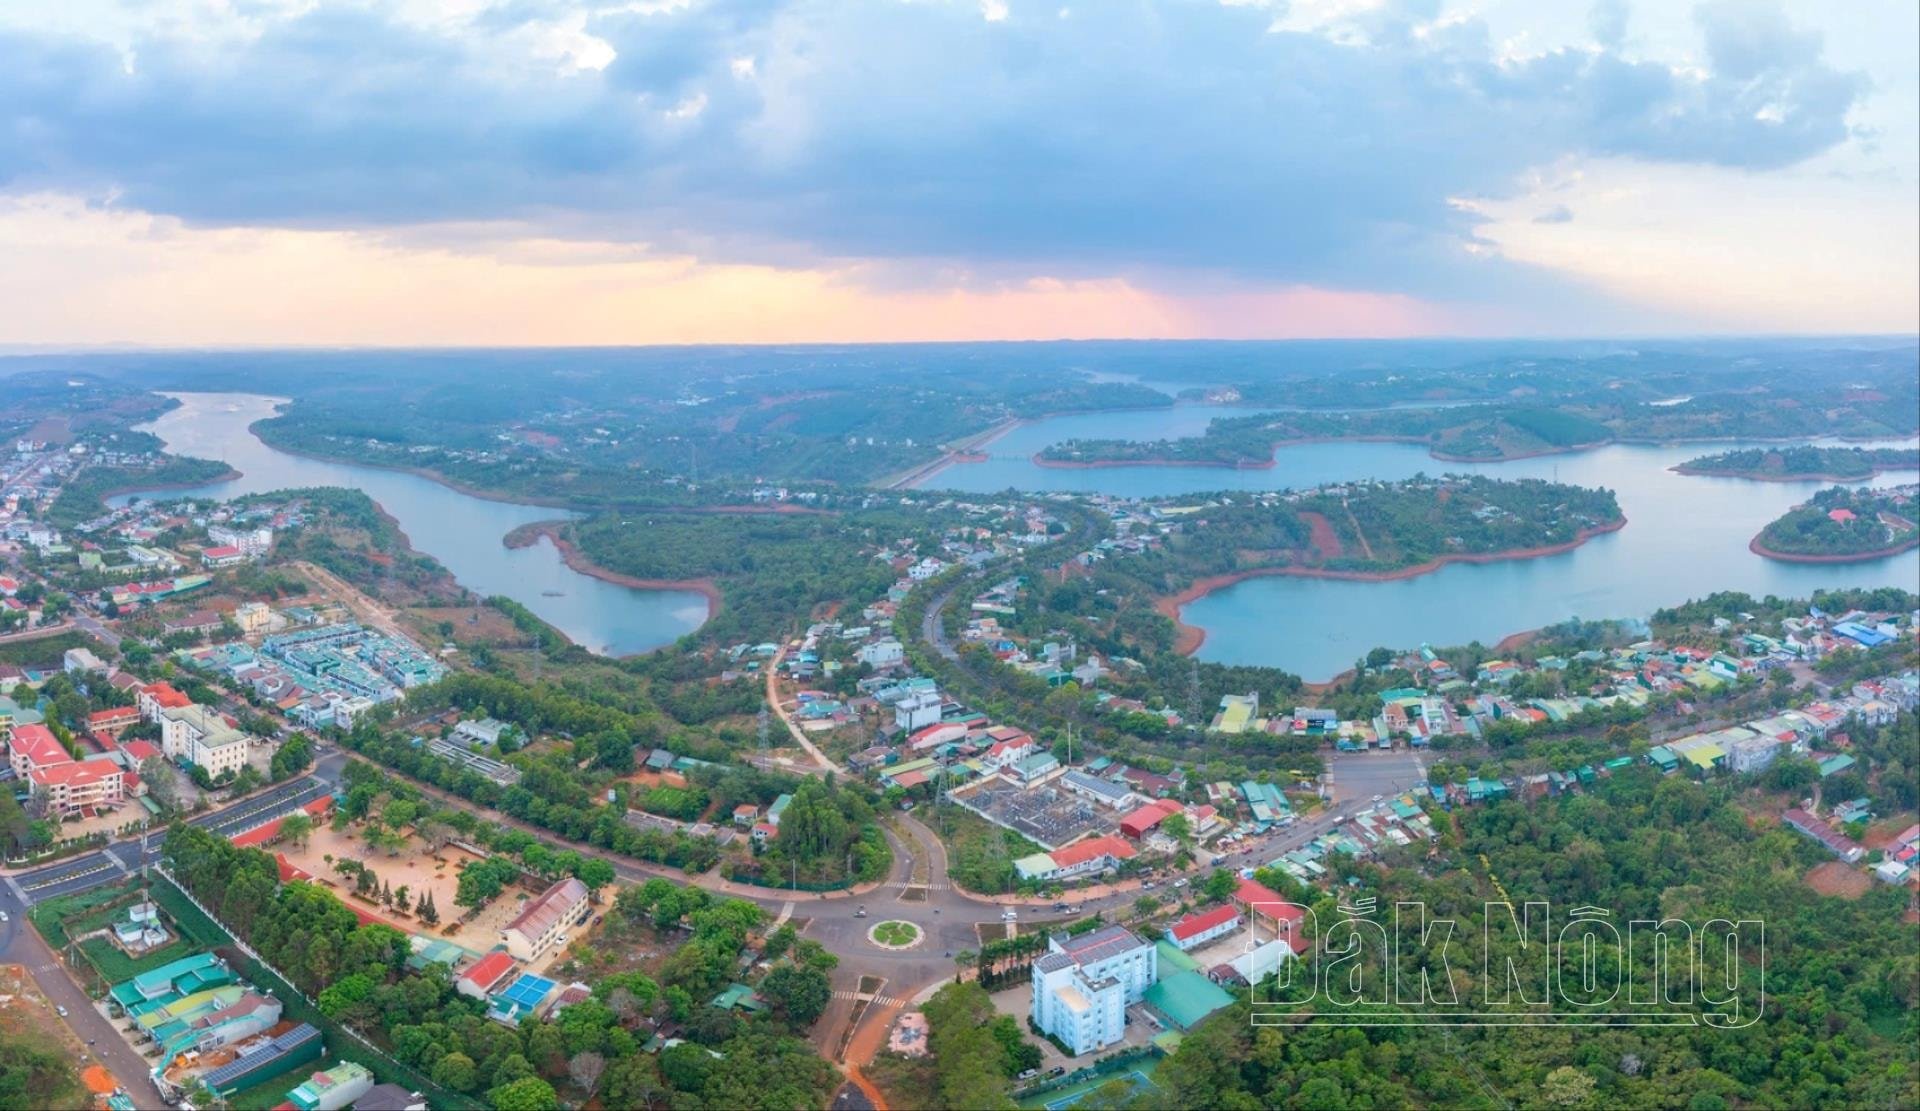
[115,393,707,656]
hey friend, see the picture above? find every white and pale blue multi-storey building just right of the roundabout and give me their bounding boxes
[1029,925,1160,1055]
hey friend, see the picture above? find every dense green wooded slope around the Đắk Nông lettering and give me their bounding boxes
[1154,769,1920,1109]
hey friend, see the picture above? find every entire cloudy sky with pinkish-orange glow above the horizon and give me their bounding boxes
[0,0,1920,347]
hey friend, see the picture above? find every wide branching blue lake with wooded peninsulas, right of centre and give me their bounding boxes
[920,405,1920,681]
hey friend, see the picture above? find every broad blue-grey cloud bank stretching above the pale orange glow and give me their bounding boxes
[0,0,1864,305]
